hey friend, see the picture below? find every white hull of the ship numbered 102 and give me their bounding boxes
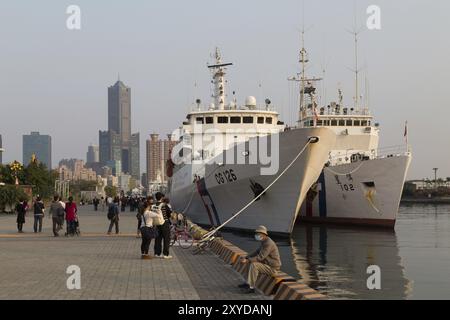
[298,154,411,229]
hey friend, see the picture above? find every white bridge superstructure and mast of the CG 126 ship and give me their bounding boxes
[176,49,285,164]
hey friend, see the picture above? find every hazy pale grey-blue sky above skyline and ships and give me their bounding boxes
[0,0,450,179]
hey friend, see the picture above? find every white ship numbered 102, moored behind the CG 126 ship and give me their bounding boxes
[299,34,411,228]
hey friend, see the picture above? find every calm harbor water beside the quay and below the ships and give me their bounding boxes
[224,204,450,299]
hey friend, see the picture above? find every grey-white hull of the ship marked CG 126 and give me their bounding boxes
[170,128,336,235]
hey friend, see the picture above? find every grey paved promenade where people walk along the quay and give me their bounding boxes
[0,206,267,300]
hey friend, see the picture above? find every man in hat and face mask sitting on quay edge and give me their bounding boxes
[239,226,281,293]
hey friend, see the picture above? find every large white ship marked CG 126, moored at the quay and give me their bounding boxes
[169,50,336,234]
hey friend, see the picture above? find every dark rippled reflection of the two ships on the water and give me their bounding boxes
[225,225,412,299]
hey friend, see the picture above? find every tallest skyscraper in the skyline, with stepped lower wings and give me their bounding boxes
[99,80,140,180]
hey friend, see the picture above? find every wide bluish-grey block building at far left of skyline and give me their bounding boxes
[22,132,52,170]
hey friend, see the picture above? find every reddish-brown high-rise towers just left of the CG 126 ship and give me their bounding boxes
[146,134,177,183]
